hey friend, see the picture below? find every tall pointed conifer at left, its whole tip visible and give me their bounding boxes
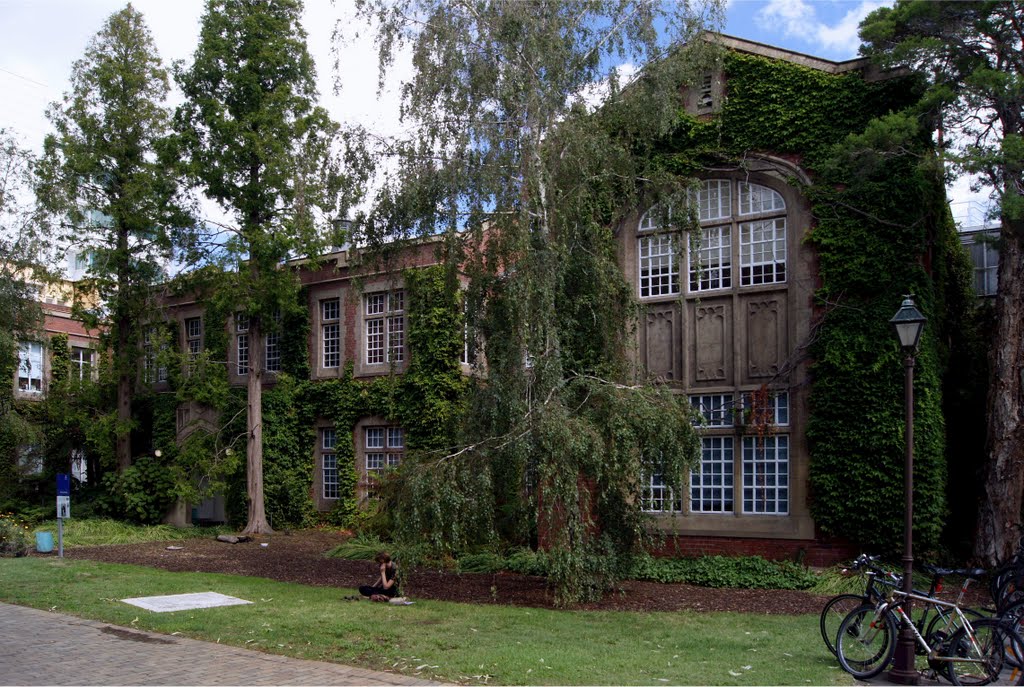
[37,4,193,470]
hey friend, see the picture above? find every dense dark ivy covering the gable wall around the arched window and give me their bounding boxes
[658,53,971,551]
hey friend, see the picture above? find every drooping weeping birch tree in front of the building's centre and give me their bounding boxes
[348,0,720,601]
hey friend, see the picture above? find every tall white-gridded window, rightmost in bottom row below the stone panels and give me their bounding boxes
[743,434,790,515]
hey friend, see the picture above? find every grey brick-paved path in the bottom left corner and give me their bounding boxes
[0,603,438,685]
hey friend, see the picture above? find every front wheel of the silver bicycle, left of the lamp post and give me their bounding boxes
[836,604,897,680]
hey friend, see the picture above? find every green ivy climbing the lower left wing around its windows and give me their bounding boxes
[142,266,466,528]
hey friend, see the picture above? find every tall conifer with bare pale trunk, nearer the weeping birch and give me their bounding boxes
[175,0,352,533]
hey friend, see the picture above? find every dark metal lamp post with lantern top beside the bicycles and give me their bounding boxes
[889,296,927,685]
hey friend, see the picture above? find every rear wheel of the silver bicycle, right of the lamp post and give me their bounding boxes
[944,618,1021,685]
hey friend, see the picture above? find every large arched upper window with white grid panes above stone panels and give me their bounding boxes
[637,179,786,298]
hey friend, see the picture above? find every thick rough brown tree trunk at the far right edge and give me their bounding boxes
[975,217,1024,566]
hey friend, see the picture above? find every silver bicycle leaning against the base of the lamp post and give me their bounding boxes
[836,570,1024,685]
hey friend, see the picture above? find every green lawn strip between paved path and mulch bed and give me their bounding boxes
[0,557,853,685]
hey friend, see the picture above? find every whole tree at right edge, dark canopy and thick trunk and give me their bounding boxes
[860,0,1024,565]
